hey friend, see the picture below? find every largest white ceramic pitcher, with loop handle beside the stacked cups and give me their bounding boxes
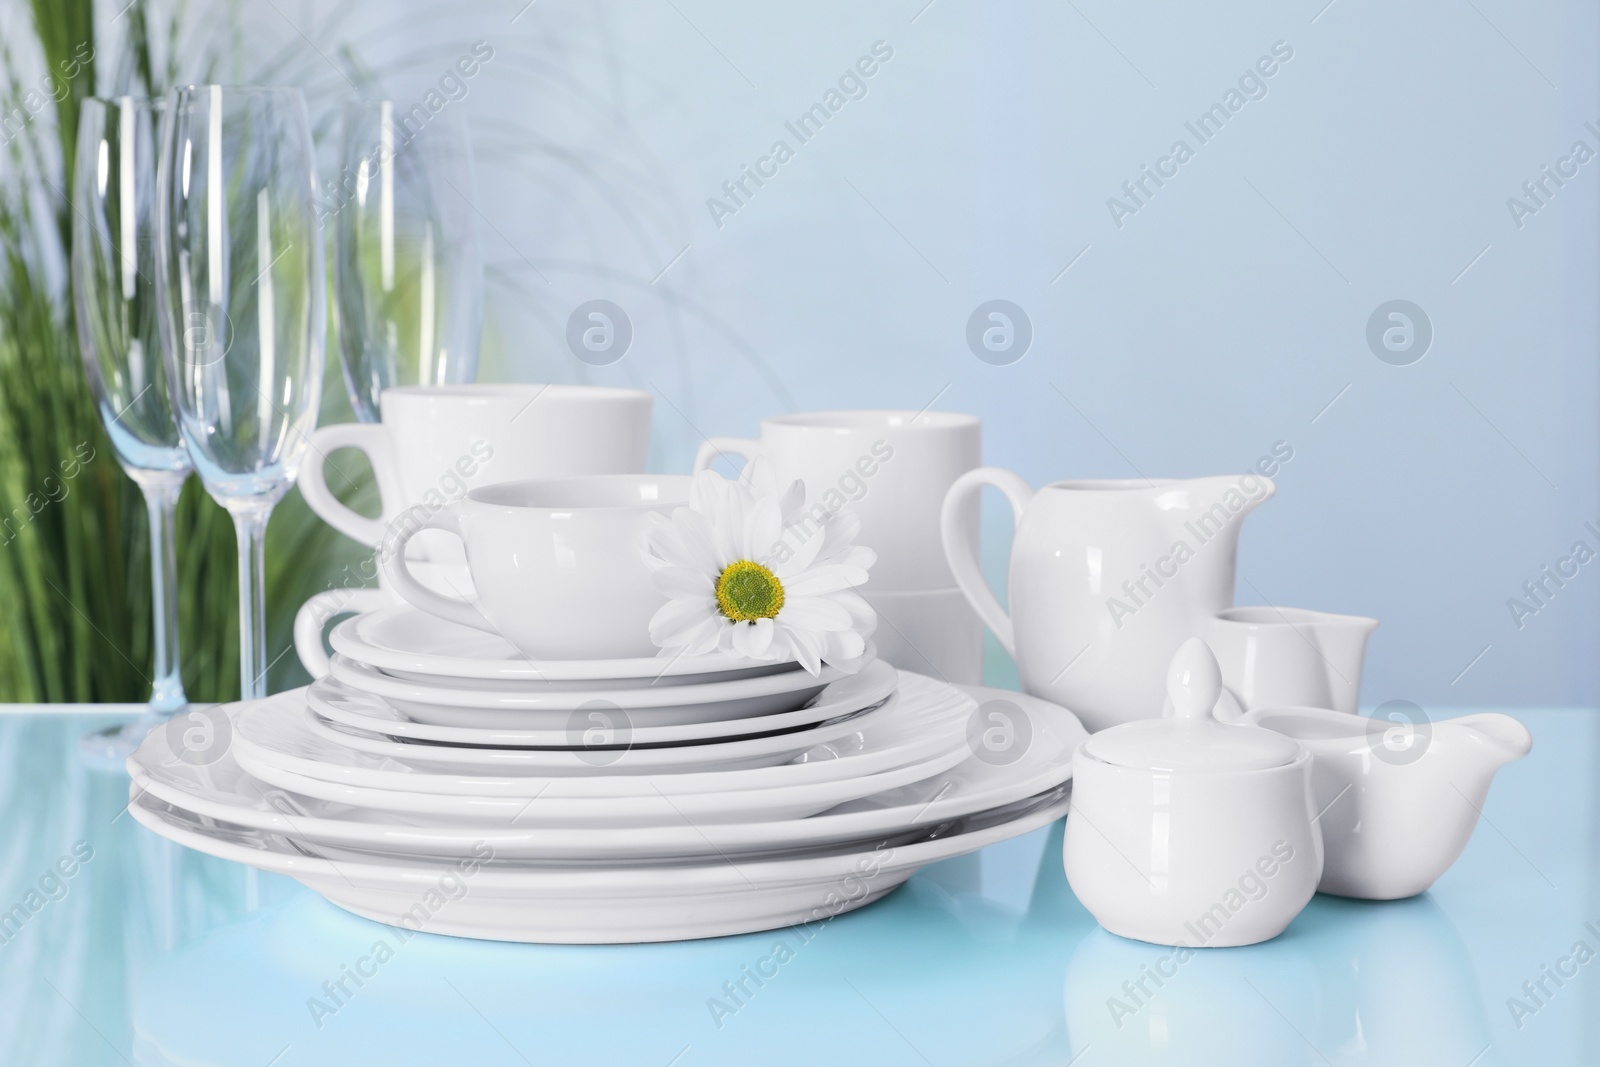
[941,467,1275,729]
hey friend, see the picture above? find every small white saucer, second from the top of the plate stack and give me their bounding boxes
[328,656,848,729]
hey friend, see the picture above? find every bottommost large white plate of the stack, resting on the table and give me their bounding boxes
[128,785,1069,944]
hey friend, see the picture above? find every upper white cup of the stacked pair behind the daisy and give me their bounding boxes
[694,411,982,592]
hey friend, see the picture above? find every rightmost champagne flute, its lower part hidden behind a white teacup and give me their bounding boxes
[334,101,483,422]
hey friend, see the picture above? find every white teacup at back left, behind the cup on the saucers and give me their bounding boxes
[299,386,651,565]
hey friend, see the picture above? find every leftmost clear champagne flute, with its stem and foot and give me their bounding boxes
[72,96,189,761]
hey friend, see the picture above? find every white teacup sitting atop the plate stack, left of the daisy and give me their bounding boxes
[379,474,691,659]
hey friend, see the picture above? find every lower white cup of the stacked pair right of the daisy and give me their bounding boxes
[862,587,984,685]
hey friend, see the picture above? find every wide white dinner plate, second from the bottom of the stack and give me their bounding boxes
[130,686,1088,862]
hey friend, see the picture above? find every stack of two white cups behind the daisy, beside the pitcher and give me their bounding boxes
[694,411,984,685]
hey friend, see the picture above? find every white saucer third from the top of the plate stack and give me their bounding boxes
[307,659,898,749]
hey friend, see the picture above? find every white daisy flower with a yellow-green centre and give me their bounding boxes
[646,459,878,675]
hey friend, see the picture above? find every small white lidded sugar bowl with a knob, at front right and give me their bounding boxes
[1062,638,1323,949]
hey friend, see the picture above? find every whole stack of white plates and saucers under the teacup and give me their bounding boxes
[128,606,1085,942]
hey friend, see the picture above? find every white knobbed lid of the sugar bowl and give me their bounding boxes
[1082,637,1301,771]
